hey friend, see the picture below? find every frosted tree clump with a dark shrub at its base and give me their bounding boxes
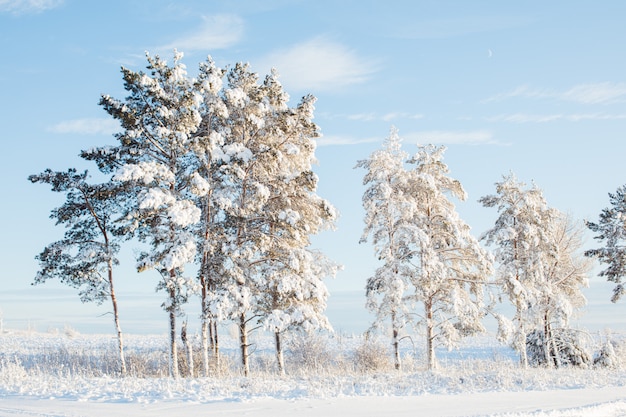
[480,174,589,366]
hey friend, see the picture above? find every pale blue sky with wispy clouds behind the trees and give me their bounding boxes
[0,0,626,331]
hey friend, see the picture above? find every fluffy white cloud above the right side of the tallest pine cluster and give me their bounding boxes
[259,37,379,92]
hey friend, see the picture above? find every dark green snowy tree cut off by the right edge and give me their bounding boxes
[585,185,626,303]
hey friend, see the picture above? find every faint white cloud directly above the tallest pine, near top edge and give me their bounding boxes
[155,14,244,52]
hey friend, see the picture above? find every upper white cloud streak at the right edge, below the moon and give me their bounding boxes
[482,82,626,104]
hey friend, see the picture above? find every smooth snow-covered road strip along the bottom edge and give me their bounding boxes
[0,387,626,417]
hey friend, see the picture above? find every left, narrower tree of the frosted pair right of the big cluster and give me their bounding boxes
[355,128,419,369]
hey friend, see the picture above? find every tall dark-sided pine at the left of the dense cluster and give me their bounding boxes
[83,52,202,377]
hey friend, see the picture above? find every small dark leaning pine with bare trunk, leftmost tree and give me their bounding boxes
[28,168,126,375]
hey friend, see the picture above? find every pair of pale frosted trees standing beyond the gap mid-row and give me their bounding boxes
[357,129,491,369]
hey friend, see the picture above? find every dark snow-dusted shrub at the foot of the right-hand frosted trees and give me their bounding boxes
[526,329,591,367]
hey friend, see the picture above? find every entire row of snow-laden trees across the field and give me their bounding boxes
[29,53,626,377]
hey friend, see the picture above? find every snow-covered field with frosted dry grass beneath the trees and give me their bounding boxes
[0,329,626,417]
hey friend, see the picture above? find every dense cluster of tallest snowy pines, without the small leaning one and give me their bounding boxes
[83,53,336,376]
